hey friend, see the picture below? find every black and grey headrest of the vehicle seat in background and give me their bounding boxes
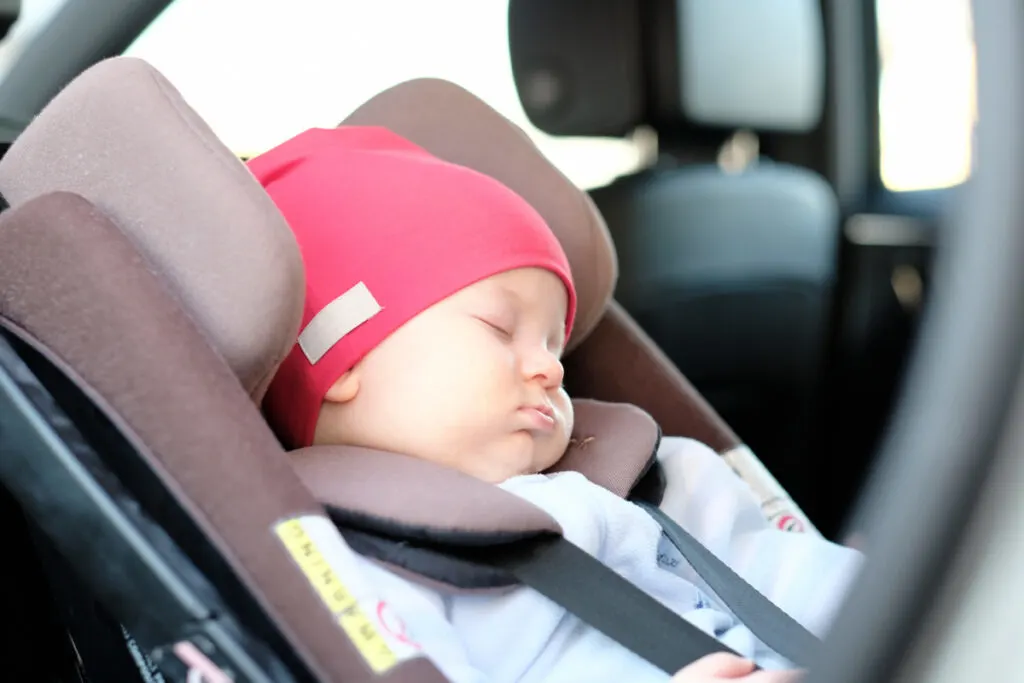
[508,0,825,136]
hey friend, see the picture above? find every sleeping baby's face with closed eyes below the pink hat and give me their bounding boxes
[314,268,572,482]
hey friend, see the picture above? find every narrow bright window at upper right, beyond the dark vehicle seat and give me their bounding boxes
[876,0,977,190]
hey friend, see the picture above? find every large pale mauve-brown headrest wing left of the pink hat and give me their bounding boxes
[0,57,304,399]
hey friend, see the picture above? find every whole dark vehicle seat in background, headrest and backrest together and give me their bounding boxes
[509,0,840,524]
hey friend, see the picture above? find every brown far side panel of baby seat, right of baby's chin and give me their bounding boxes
[565,301,740,453]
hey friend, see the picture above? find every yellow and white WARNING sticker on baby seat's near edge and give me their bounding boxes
[274,515,417,674]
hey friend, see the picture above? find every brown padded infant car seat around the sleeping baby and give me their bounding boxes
[0,58,815,682]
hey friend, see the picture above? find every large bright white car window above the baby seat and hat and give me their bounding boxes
[126,0,644,188]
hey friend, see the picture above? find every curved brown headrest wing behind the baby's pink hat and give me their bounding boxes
[342,79,617,348]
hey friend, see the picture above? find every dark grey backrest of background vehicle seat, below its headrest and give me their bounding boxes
[592,163,840,501]
